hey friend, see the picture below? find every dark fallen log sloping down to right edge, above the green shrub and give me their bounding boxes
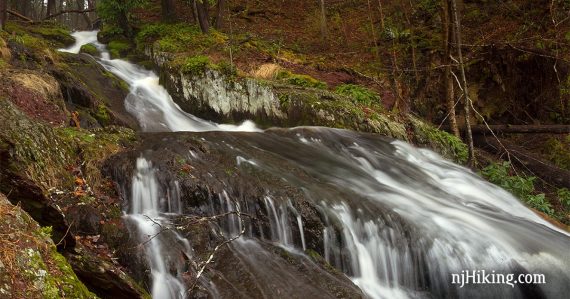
[475,136,570,188]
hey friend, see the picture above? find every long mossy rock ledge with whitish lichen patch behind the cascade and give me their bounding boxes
[146,49,467,162]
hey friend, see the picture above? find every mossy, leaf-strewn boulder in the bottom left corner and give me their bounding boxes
[0,193,97,298]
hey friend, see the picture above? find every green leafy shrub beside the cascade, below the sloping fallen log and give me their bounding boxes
[481,162,554,215]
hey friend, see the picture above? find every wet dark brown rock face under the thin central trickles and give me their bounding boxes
[105,132,363,298]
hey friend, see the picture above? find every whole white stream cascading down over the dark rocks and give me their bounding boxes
[63,32,570,298]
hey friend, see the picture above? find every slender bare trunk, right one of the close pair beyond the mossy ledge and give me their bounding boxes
[451,0,475,166]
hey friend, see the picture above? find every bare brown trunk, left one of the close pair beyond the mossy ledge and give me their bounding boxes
[442,0,461,137]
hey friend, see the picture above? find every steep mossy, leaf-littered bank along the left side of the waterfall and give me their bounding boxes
[0,24,149,298]
